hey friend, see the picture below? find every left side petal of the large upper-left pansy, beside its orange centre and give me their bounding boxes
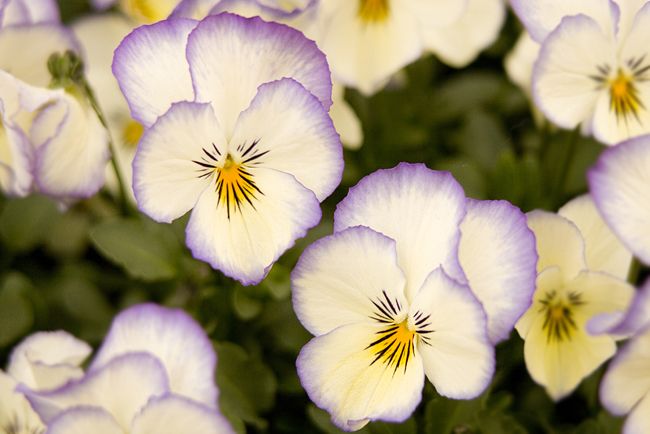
[133,102,226,223]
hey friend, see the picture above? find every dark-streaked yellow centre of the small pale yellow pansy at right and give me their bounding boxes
[540,290,584,343]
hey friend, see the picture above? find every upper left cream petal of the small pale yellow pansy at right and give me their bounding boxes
[526,211,587,281]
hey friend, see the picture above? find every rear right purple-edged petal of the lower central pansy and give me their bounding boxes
[458,199,537,343]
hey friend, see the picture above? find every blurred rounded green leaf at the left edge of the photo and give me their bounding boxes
[0,195,59,252]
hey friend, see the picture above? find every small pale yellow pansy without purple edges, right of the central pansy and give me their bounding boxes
[517,196,634,400]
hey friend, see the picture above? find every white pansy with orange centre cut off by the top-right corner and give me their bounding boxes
[513,0,650,145]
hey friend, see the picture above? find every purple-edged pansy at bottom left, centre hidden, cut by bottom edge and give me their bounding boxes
[21,304,233,434]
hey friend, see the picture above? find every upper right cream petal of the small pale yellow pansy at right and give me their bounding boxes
[558,195,632,279]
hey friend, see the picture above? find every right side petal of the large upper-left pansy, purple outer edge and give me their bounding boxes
[230,78,343,201]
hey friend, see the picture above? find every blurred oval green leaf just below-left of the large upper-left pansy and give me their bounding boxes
[90,219,180,281]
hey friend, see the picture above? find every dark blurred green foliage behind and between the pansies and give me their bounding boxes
[0,0,621,434]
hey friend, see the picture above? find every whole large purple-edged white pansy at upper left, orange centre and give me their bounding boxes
[113,14,343,284]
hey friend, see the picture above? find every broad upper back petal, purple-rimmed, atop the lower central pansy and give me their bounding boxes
[334,163,466,300]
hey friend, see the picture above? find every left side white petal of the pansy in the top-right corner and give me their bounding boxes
[533,15,617,129]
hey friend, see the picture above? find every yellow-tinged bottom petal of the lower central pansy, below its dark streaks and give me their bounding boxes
[296,323,424,431]
